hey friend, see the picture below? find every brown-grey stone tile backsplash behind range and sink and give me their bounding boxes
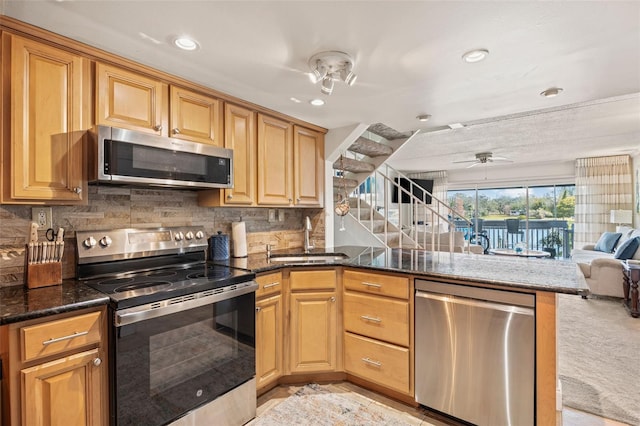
[0,186,324,287]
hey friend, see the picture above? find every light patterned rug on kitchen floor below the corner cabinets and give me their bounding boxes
[249,383,420,426]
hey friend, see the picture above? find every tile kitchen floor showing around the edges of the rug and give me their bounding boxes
[254,382,627,426]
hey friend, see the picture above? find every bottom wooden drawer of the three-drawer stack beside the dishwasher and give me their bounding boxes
[344,333,410,393]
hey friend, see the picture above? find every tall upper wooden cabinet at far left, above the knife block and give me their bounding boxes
[2,34,90,204]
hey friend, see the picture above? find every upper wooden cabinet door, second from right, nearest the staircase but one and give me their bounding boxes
[258,114,293,206]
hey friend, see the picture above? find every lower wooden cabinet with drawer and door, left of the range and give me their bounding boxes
[0,307,109,426]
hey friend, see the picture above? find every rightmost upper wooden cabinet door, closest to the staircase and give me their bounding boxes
[293,126,324,207]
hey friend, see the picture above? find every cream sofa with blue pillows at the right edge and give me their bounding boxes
[571,228,640,297]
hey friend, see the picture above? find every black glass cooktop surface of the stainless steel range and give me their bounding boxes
[83,263,255,309]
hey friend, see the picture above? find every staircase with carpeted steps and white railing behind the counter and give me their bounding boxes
[333,123,472,248]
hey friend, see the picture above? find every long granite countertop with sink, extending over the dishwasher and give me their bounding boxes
[221,246,589,294]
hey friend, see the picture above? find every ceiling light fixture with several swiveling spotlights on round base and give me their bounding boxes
[309,50,358,95]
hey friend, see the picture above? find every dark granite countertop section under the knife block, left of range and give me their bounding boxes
[0,280,109,325]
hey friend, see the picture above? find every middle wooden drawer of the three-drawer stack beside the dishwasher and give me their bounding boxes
[343,292,409,346]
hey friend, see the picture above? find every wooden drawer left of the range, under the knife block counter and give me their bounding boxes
[20,312,102,362]
